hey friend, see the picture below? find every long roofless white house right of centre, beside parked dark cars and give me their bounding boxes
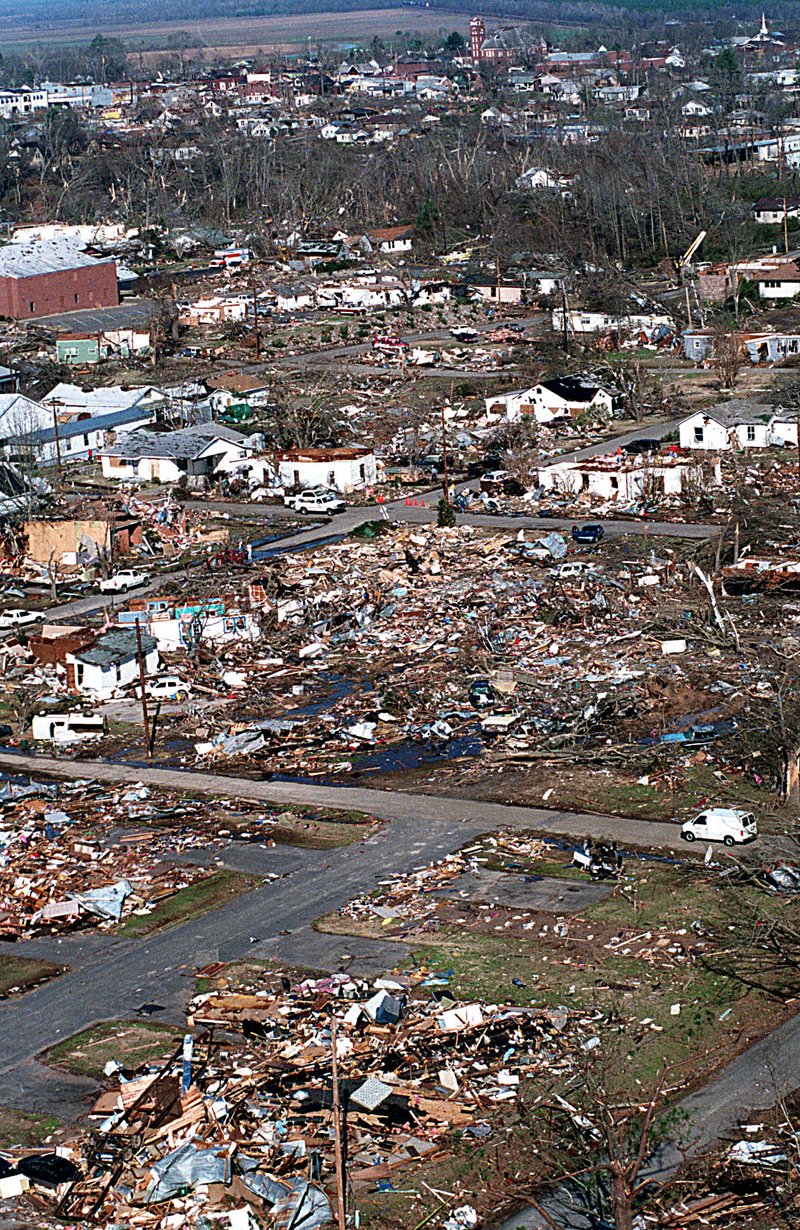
[538,454,722,503]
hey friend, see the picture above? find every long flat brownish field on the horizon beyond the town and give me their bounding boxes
[0,9,472,55]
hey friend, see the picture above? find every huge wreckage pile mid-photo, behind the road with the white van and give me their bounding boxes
[185,526,753,776]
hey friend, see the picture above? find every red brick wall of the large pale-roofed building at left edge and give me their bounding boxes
[0,261,119,320]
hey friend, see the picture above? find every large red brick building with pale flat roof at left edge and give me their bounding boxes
[0,240,119,320]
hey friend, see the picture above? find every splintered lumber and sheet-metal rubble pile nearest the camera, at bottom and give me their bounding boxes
[6,972,585,1230]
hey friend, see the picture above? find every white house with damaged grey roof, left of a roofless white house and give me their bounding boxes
[100,423,252,482]
